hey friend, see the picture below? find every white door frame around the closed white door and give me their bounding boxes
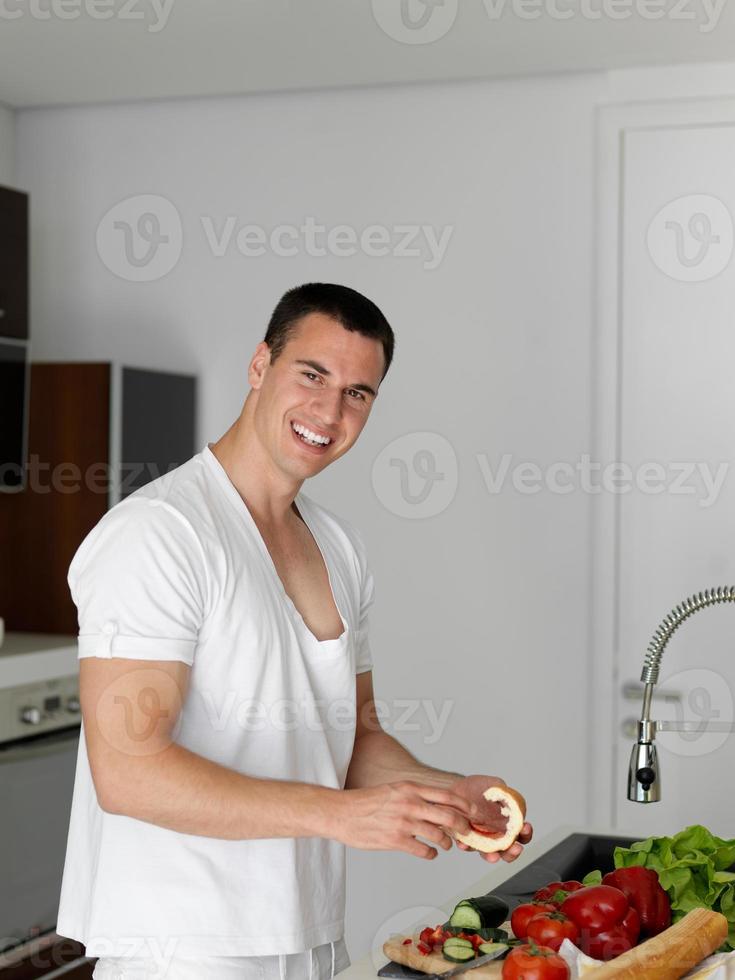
[587,97,735,829]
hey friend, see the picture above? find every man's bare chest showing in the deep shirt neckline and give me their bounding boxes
[261,520,343,640]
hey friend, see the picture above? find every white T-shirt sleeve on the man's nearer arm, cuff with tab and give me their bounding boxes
[68,497,207,665]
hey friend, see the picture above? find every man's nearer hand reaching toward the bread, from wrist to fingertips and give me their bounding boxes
[330,780,470,861]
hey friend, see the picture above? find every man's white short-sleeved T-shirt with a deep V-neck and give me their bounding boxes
[57,446,373,957]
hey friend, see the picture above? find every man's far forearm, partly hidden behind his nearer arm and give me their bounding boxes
[345,670,462,789]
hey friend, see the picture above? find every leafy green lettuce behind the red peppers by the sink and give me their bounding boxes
[614,824,735,950]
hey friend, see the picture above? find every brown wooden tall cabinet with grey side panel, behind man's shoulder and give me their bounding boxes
[0,363,197,634]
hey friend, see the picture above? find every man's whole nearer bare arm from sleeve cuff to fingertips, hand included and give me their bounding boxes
[79,657,469,860]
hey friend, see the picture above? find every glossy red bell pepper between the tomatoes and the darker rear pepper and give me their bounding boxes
[561,885,641,960]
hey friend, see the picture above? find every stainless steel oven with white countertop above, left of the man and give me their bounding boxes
[0,634,80,953]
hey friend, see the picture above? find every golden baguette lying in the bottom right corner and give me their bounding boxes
[585,909,728,980]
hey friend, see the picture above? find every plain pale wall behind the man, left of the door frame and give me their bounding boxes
[18,76,604,958]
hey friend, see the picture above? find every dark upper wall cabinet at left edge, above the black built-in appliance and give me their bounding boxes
[0,187,28,340]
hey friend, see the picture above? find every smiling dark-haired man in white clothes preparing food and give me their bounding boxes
[57,284,531,980]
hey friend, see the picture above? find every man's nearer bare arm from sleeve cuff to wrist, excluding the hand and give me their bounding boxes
[80,658,344,840]
